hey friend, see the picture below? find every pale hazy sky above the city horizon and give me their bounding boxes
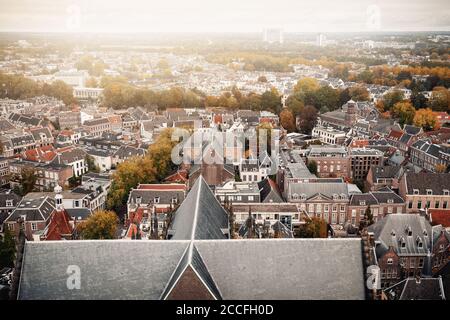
[0,0,450,32]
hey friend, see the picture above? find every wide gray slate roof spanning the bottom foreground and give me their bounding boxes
[18,239,365,300]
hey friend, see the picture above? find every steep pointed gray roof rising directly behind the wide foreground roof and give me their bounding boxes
[169,176,229,240]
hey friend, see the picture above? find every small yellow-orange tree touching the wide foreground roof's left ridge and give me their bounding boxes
[78,210,119,240]
